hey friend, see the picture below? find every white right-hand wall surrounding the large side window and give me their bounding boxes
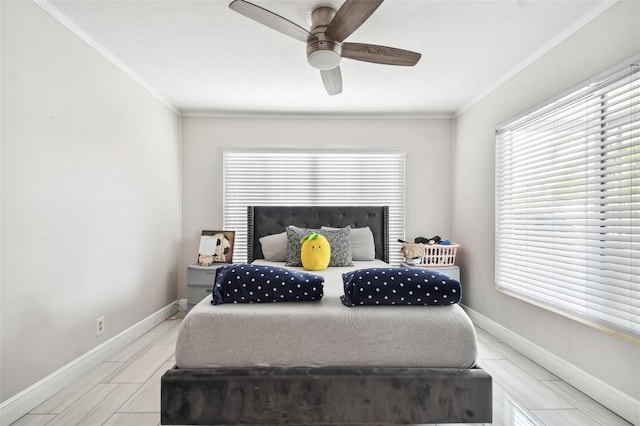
[452,1,640,412]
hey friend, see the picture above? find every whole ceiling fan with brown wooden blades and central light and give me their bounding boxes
[229,0,422,95]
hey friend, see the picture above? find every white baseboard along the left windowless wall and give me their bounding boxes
[0,301,178,426]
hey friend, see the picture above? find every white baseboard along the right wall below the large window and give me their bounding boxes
[464,306,640,425]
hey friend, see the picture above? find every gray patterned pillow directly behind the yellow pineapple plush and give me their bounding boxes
[286,225,353,266]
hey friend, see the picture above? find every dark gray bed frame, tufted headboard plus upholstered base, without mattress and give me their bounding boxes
[161,206,492,425]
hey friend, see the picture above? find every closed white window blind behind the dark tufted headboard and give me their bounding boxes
[223,150,405,263]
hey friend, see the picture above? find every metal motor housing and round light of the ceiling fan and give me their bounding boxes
[307,7,342,70]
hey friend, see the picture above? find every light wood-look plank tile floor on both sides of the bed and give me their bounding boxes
[12,313,630,426]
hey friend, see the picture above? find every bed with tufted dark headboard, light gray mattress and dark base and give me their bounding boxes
[161,206,492,425]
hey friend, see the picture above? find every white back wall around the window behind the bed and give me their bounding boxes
[180,117,452,298]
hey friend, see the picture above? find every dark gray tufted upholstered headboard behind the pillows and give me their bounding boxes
[247,206,389,262]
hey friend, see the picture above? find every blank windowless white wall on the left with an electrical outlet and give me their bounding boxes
[0,1,181,401]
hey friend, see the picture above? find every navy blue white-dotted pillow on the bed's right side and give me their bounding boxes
[340,267,462,307]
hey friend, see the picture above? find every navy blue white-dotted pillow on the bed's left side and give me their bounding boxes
[211,263,324,305]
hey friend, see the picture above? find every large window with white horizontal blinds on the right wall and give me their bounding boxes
[495,63,640,338]
